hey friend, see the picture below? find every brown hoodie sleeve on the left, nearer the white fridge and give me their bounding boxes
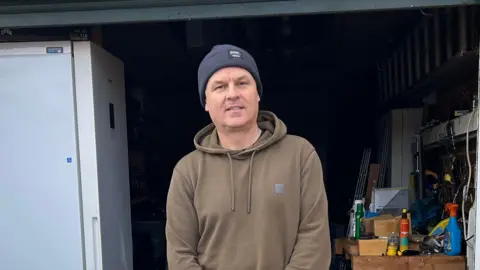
[165,168,202,270]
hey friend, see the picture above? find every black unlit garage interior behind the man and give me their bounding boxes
[0,3,478,270]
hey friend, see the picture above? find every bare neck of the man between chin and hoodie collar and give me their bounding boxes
[217,123,261,150]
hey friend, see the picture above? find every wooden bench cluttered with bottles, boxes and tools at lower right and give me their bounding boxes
[335,154,474,270]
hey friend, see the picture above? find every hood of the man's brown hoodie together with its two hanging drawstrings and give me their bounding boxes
[193,111,287,214]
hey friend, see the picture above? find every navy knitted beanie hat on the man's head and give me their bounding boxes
[198,44,262,107]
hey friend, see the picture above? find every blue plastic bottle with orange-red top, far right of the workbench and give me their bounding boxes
[443,203,462,256]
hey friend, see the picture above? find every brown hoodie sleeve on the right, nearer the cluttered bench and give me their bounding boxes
[286,150,331,270]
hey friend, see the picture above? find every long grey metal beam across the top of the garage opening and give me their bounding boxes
[0,0,480,28]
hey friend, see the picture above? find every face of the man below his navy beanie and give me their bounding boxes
[205,67,260,129]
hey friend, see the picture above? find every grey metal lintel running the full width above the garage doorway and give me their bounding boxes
[0,0,480,28]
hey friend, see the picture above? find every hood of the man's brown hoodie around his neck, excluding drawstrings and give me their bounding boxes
[193,111,287,156]
